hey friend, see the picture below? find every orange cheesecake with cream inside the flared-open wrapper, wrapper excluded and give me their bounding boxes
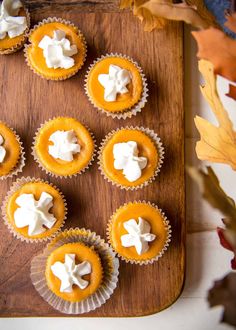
[45,243,103,302]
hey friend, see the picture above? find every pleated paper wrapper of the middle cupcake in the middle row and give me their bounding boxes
[31,117,97,179]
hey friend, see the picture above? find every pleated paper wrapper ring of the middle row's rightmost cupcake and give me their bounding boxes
[98,126,164,190]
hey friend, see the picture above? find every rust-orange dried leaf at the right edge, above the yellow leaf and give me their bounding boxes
[192,28,236,81]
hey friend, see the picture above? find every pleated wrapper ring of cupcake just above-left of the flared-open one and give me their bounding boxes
[1,177,67,243]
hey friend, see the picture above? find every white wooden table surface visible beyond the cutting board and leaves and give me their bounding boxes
[0,27,236,330]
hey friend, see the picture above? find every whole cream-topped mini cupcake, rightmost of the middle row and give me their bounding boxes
[98,127,164,190]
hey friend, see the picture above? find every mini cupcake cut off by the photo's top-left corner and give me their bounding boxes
[0,0,30,55]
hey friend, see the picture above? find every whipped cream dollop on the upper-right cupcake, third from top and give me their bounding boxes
[98,64,132,102]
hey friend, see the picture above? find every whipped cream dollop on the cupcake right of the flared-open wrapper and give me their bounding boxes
[121,217,156,255]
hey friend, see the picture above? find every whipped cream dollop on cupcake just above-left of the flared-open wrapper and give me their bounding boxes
[14,192,57,236]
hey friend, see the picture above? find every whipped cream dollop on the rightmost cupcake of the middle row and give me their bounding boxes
[113,141,147,182]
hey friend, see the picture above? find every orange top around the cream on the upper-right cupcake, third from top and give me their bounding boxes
[87,56,143,112]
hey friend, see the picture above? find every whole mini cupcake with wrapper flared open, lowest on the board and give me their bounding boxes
[31,228,119,314]
